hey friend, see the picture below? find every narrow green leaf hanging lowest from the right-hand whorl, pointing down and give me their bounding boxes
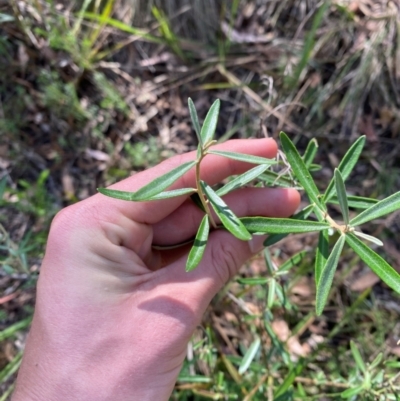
[315,234,345,316]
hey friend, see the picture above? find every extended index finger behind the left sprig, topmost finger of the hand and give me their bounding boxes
[93,138,277,224]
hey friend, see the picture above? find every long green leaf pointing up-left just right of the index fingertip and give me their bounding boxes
[280,132,326,211]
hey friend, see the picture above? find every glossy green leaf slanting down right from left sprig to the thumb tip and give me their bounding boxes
[200,181,251,241]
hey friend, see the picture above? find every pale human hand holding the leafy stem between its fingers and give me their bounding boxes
[13,139,300,401]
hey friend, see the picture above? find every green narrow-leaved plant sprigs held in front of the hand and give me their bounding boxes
[99,99,400,315]
